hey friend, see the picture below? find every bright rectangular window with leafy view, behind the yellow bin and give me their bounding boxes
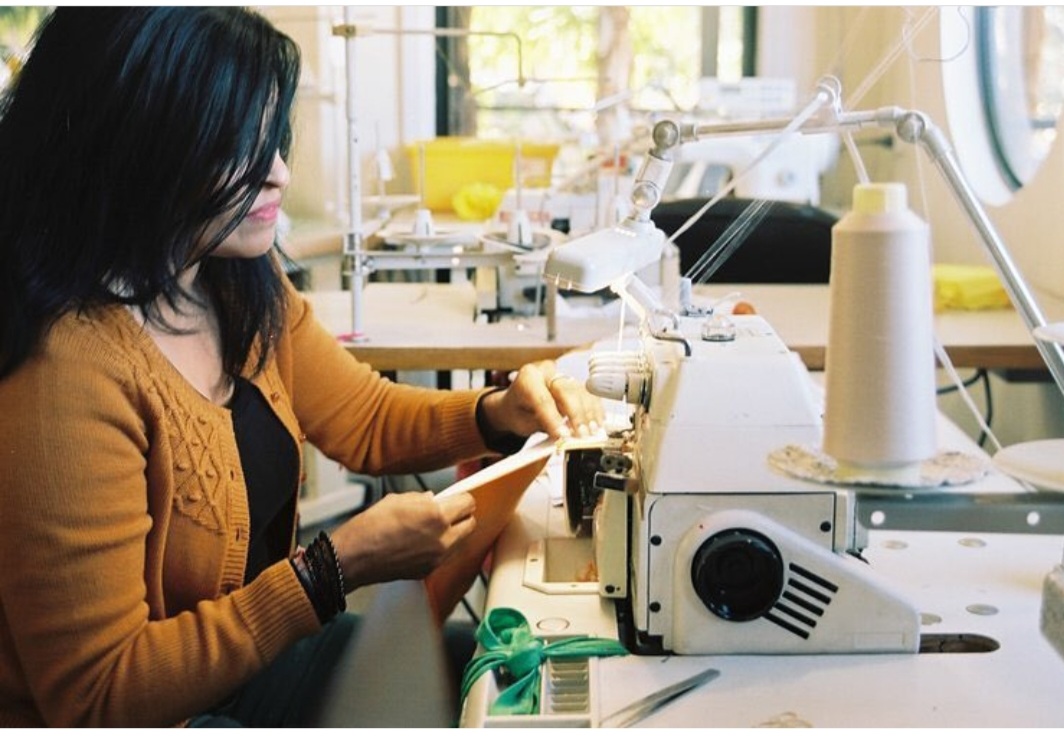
[437,5,755,147]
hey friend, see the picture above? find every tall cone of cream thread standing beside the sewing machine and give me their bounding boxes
[824,183,936,485]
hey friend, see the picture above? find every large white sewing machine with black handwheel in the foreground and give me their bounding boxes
[563,304,919,654]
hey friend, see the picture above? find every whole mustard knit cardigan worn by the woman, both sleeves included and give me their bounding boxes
[0,282,486,726]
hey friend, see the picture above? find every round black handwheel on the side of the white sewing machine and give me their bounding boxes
[691,529,783,621]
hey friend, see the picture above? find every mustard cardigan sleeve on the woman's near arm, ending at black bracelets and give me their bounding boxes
[0,321,318,726]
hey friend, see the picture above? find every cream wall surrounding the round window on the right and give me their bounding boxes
[759,6,1064,445]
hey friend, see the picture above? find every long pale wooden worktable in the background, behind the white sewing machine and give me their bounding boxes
[309,283,1064,370]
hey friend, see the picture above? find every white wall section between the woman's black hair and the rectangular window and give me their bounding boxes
[261,5,436,225]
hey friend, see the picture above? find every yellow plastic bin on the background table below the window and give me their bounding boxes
[406,136,559,212]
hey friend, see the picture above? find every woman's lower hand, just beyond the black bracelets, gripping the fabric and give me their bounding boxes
[331,491,477,592]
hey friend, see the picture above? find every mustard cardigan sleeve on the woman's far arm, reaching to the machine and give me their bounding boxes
[278,280,487,474]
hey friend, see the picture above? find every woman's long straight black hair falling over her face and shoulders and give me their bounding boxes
[0,7,300,378]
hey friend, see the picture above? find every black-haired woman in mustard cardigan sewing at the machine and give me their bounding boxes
[0,7,601,725]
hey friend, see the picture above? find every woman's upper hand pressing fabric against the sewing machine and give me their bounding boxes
[481,361,605,439]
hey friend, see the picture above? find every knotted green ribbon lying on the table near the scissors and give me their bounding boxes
[462,608,628,716]
